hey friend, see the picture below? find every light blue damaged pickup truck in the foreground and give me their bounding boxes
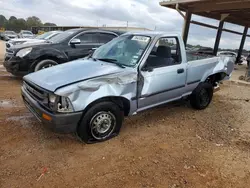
[22,32,234,143]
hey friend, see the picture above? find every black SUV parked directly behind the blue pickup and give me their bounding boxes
[4,29,122,76]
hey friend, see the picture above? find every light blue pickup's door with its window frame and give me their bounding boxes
[138,37,187,110]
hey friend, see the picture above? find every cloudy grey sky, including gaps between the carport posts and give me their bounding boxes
[0,0,250,50]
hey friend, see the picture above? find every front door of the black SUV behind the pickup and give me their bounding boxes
[67,32,100,60]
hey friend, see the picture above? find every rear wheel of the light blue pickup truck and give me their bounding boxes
[190,82,214,110]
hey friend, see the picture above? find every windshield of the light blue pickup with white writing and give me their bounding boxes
[92,35,150,67]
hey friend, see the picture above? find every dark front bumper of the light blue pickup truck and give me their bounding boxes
[21,87,82,133]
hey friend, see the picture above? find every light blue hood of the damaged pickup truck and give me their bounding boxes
[24,59,126,91]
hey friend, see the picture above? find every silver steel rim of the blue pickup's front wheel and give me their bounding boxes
[90,111,116,140]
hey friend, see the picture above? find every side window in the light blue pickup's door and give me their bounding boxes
[146,37,181,68]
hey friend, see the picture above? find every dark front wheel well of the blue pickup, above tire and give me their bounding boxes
[83,97,130,116]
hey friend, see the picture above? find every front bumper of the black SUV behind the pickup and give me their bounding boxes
[3,53,32,76]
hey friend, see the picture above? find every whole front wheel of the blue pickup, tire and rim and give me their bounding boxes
[77,101,124,143]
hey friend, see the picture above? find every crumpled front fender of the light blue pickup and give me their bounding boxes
[55,68,138,114]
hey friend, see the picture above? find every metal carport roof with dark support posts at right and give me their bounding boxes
[160,0,250,59]
